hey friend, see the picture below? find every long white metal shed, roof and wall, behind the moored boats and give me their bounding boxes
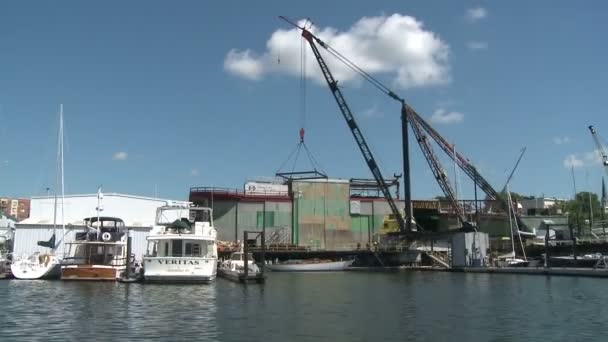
[13,193,188,260]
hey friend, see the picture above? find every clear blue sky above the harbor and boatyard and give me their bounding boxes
[0,1,608,199]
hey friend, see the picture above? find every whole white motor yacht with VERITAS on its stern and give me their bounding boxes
[143,205,217,283]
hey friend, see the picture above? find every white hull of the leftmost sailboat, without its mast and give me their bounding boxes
[11,253,61,280]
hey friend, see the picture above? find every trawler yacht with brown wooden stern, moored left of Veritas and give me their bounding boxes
[61,217,131,281]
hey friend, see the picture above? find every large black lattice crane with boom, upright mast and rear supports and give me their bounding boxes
[280,16,507,233]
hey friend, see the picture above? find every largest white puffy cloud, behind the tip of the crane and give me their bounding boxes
[224,13,450,88]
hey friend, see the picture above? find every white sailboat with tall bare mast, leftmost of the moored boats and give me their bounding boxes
[11,105,65,280]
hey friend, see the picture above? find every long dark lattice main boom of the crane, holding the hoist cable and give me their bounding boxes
[296,25,407,233]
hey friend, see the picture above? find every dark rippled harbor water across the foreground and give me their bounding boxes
[0,271,608,342]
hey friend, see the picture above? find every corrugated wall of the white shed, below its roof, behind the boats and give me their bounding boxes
[13,224,151,260]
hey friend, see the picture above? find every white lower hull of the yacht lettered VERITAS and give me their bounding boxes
[144,257,217,283]
